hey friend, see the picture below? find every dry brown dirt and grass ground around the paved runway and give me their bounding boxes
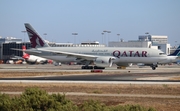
[0,72,180,111]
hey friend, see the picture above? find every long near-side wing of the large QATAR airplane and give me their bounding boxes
[40,49,115,60]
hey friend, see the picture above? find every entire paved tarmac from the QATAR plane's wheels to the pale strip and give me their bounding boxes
[0,65,180,84]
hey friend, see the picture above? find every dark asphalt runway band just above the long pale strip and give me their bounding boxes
[0,73,180,82]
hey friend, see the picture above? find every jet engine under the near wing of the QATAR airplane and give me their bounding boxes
[94,57,113,67]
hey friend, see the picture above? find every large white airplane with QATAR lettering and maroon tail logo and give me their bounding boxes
[13,23,177,70]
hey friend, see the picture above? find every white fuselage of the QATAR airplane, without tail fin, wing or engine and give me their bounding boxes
[26,47,172,63]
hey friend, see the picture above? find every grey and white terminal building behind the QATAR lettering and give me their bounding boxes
[108,35,170,55]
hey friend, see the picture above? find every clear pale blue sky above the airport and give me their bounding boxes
[0,0,180,46]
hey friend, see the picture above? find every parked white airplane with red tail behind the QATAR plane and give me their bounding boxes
[22,45,52,64]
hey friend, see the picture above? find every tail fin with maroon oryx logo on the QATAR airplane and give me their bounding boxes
[25,23,48,48]
